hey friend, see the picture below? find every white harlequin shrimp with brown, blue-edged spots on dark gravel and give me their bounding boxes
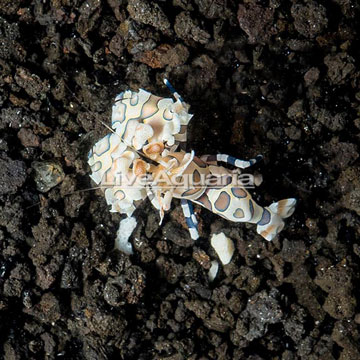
[88,80,296,241]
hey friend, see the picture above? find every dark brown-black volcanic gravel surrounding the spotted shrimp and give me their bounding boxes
[0,0,360,360]
